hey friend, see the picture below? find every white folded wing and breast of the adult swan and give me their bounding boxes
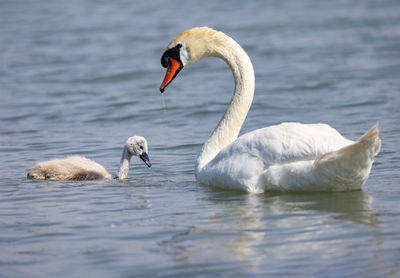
[198,123,353,192]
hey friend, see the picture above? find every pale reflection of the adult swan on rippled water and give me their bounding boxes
[159,191,382,273]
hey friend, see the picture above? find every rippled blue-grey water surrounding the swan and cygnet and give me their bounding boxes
[0,0,400,277]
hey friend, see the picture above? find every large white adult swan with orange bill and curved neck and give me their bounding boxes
[160,27,381,192]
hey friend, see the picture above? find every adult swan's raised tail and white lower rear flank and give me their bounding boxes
[260,125,381,191]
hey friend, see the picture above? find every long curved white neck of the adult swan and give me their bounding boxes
[196,32,254,173]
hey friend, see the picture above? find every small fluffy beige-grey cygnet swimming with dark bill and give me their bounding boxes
[28,136,151,180]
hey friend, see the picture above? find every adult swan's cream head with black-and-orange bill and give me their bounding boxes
[160,27,223,93]
